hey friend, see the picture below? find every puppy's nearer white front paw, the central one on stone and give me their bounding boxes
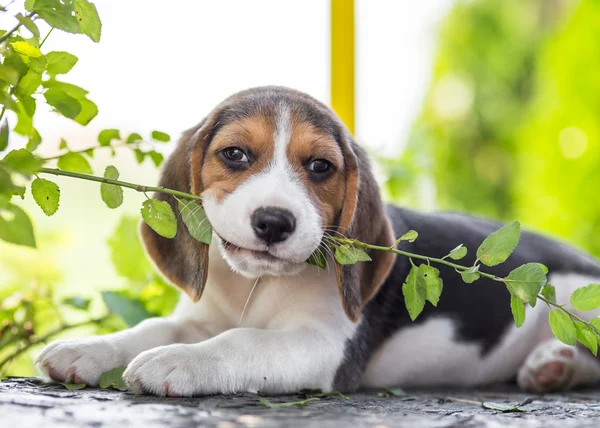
[123,344,223,397]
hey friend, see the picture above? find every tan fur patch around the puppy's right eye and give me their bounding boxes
[286,114,346,232]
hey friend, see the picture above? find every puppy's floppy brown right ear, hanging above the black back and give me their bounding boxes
[335,132,396,322]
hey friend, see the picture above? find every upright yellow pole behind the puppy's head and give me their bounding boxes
[331,0,354,134]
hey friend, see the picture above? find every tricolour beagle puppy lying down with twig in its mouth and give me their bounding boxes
[37,87,600,396]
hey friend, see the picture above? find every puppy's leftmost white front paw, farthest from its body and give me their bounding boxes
[35,337,125,385]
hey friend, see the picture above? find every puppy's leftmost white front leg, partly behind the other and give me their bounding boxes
[35,317,210,385]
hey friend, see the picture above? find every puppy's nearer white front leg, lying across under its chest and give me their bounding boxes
[123,326,346,396]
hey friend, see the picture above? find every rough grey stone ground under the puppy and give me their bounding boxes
[0,378,600,428]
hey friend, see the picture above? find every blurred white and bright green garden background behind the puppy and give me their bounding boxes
[0,0,600,375]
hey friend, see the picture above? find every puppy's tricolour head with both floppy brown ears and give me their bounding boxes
[142,87,394,321]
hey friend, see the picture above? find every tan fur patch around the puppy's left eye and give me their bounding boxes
[201,115,275,202]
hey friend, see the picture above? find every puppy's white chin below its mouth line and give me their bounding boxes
[218,237,308,278]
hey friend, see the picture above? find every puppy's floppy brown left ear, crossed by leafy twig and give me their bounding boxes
[140,112,218,302]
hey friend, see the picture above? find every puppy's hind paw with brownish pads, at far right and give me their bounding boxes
[517,339,579,392]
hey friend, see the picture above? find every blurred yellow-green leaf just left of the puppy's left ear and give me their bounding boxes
[108,216,152,283]
